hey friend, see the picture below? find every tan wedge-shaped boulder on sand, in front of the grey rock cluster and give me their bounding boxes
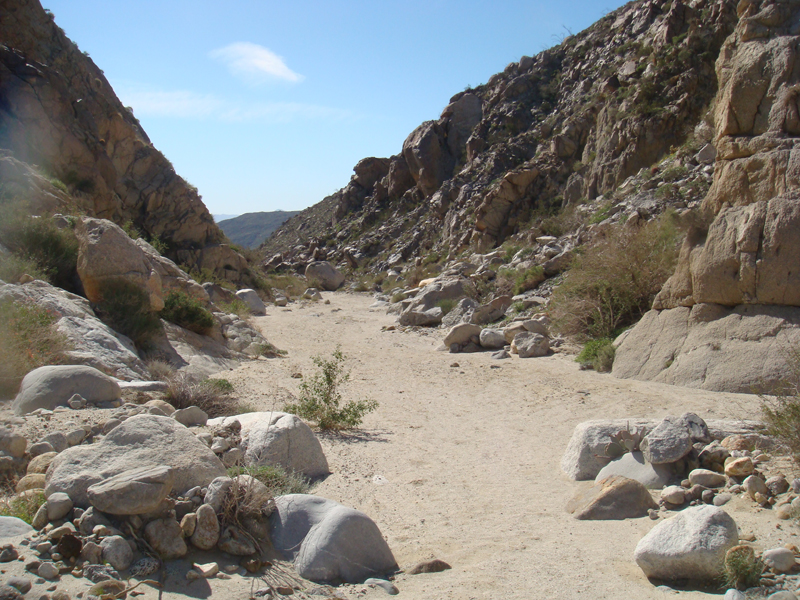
[567,475,658,520]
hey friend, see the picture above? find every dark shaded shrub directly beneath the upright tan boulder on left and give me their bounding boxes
[95,278,161,349]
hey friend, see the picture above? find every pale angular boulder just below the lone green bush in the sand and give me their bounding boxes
[209,412,330,479]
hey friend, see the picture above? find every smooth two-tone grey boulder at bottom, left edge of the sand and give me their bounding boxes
[270,494,397,583]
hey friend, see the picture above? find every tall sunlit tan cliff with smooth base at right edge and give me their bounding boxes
[614,0,800,392]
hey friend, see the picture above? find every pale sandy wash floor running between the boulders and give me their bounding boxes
[226,293,797,600]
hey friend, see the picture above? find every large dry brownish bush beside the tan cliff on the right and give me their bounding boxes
[552,214,681,338]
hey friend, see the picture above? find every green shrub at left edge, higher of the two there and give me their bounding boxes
[0,206,78,292]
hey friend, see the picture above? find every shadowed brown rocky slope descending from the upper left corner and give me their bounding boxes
[0,0,247,280]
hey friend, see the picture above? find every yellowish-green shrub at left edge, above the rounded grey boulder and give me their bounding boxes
[0,298,68,398]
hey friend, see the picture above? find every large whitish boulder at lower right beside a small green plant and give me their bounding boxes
[633,506,739,583]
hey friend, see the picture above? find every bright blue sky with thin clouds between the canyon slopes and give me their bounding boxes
[42,0,623,214]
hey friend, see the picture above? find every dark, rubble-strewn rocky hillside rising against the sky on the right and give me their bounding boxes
[263,0,737,271]
